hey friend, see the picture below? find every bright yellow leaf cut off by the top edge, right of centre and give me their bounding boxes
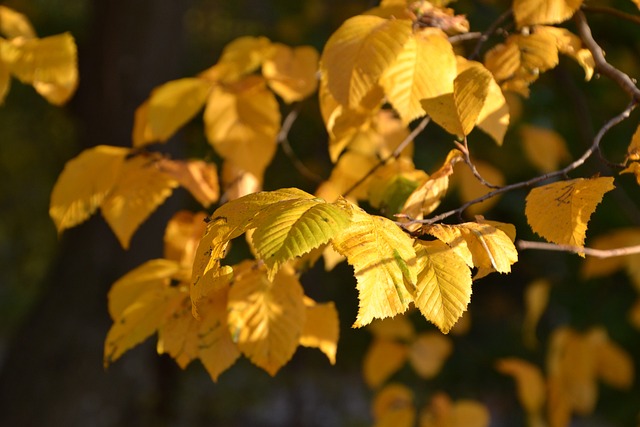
[513,0,582,28]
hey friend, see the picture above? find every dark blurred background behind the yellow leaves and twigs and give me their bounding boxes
[0,0,640,427]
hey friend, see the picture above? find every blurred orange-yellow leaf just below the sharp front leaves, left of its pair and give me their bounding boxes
[362,338,409,388]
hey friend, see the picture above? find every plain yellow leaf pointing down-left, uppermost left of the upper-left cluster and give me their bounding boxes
[133,77,211,147]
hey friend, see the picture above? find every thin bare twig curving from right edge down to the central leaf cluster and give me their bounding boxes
[403,103,637,226]
